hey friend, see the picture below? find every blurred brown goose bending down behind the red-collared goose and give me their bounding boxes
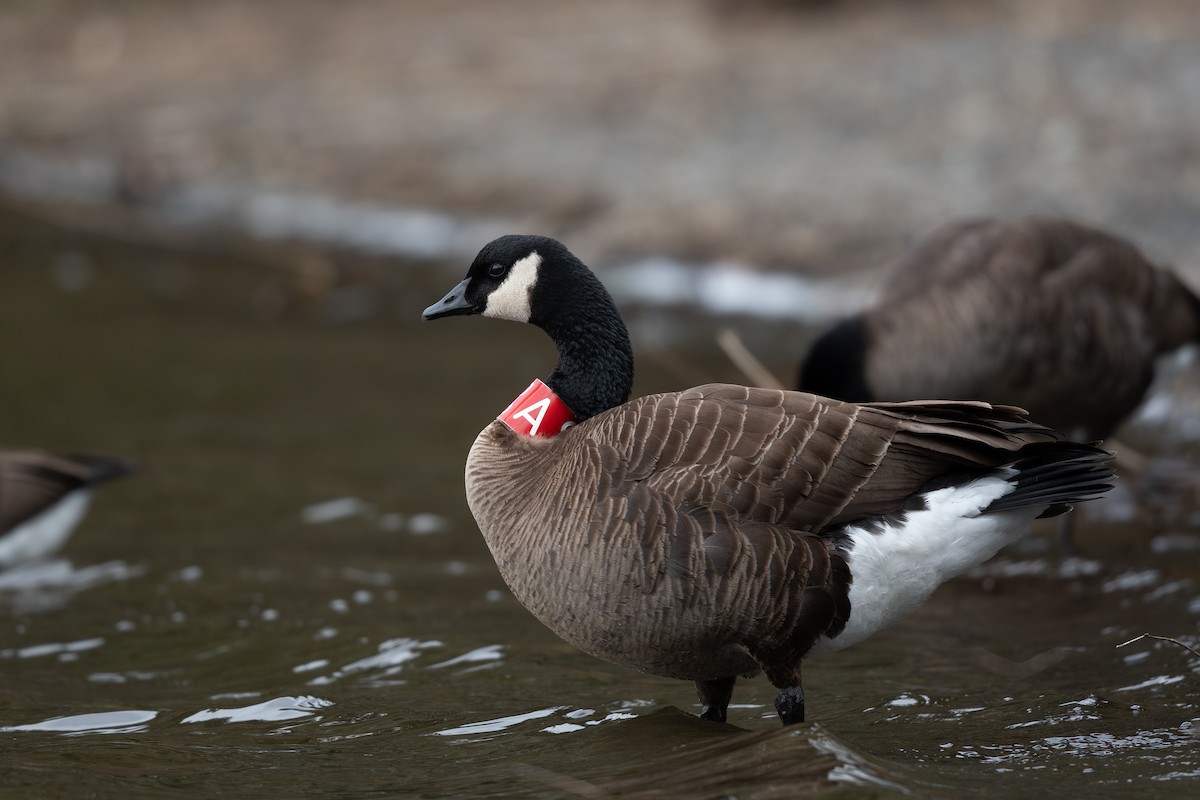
[798,217,1200,441]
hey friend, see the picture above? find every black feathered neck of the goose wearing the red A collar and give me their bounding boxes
[529,253,634,422]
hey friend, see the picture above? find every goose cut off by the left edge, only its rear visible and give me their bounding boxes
[0,450,133,570]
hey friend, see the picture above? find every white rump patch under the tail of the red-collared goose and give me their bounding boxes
[810,470,1045,655]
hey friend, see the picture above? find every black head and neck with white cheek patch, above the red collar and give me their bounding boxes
[421,235,634,421]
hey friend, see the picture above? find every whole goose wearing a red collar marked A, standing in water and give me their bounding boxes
[422,235,1112,724]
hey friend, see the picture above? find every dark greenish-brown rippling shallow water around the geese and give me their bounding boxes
[0,209,1200,798]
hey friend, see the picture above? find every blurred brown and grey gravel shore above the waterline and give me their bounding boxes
[0,0,1200,278]
